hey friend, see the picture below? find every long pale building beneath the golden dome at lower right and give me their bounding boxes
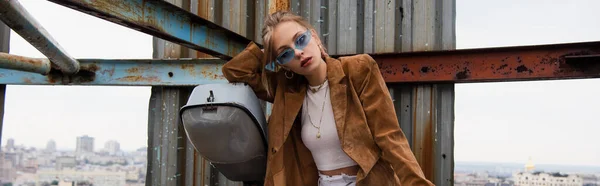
[513,172,583,186]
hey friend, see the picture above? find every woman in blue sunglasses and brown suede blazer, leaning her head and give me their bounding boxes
[223,12,433,186]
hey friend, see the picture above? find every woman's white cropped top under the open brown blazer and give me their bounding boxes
[302,81,357,171]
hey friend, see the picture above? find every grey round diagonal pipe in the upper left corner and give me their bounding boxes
[0,0,79,74]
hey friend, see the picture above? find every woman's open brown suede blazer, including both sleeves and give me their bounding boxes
[223,43,433,186]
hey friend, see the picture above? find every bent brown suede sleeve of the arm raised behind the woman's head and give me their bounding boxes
[222,42,276,103]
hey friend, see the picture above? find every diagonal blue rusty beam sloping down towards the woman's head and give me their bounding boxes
[50,0,250,60]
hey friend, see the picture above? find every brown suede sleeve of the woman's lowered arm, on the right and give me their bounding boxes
[359,55,433,185]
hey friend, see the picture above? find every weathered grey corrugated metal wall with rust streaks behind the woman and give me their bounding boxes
[148,0,455,185]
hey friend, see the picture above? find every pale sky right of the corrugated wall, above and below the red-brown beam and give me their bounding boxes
[454,0,600,166]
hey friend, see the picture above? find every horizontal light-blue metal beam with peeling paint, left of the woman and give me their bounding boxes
[0,53,227,86]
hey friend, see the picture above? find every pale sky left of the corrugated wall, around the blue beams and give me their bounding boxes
[2,0,152,151]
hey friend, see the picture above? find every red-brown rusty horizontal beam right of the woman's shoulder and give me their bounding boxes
[371,42,600,83]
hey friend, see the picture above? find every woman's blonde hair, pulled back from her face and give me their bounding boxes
[261,11,323,96]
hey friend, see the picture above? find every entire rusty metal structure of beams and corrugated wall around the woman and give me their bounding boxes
[0,0,600,185]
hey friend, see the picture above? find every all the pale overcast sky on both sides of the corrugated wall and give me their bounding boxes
[2,0,600,166]
